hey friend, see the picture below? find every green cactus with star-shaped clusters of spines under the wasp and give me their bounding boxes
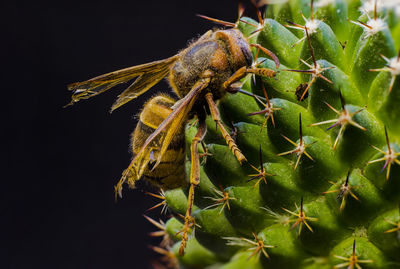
[148,0,400,269]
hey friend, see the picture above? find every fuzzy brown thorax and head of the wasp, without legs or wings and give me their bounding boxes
[169,29,252,100]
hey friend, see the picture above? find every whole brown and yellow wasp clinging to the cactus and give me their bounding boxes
[69,29,279,254]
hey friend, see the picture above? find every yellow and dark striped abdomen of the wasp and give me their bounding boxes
[131,95,187,190]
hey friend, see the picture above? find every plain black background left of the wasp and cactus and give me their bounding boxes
[4,0,245,268]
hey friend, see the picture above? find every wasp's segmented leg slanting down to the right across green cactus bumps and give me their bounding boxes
[205,93,247,163]
